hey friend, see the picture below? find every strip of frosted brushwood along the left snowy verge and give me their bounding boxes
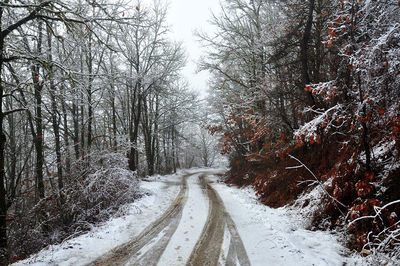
[9,153,141,259]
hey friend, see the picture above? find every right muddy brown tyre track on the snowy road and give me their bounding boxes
[187,175,250,266]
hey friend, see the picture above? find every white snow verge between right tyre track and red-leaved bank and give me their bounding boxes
[210,177,365,265]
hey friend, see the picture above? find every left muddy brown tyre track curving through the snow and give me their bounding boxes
[88,175,190,266]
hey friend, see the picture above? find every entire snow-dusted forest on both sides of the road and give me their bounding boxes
[0,0,400,264]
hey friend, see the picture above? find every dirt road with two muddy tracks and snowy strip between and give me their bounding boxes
[89,173,250,265]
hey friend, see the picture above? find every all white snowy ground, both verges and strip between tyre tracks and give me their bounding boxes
[14,169,365,265]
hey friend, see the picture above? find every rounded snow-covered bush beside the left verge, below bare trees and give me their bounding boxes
[64,153,140,227]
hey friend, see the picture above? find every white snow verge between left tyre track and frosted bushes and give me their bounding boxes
[13,173,183,266]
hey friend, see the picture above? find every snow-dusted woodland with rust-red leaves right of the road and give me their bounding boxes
[203,0,400,264]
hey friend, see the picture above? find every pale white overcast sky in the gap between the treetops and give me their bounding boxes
[168,0,219,97]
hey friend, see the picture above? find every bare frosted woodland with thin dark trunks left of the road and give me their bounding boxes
[0,0,219,264]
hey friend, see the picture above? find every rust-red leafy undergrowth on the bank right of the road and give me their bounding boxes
[228,134,400,259]
